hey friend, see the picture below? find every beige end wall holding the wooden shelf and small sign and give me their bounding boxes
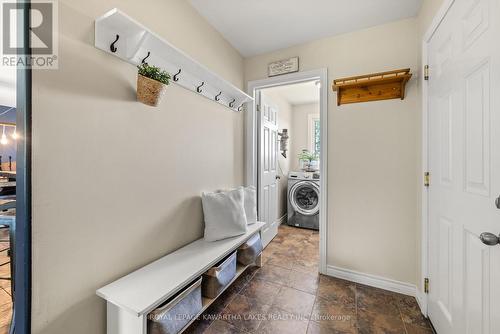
[245,19,420,283]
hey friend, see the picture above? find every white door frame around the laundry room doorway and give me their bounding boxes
[245,68,328,274]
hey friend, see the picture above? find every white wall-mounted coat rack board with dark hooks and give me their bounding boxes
[95,8,253,111]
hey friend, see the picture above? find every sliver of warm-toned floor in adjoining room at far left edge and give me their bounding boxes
[0,233,12,334]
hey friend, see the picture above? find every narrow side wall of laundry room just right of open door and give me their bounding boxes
[263,88,293,221]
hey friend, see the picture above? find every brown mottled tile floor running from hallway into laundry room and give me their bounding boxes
[187,226,433,334]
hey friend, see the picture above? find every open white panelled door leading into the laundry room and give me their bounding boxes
[257,92,278,247]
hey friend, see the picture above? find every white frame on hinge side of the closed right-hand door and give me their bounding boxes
[422,0,455,317]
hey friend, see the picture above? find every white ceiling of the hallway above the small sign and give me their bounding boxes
[189,0,422,57]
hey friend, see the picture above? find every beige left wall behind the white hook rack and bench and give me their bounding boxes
[33,0,244,334]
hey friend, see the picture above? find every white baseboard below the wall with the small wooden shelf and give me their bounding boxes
[326,266,418,300]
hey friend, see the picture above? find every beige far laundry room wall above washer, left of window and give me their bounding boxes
[290,103,319,171]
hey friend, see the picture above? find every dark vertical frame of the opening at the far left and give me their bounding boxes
[9,0,32,334]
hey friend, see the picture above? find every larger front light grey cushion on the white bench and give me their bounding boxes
[201,188,247,241]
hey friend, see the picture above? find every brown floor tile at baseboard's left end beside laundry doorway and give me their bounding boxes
[318,275,355,307]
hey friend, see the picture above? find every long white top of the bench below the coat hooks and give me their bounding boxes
[97,222,265,317]
